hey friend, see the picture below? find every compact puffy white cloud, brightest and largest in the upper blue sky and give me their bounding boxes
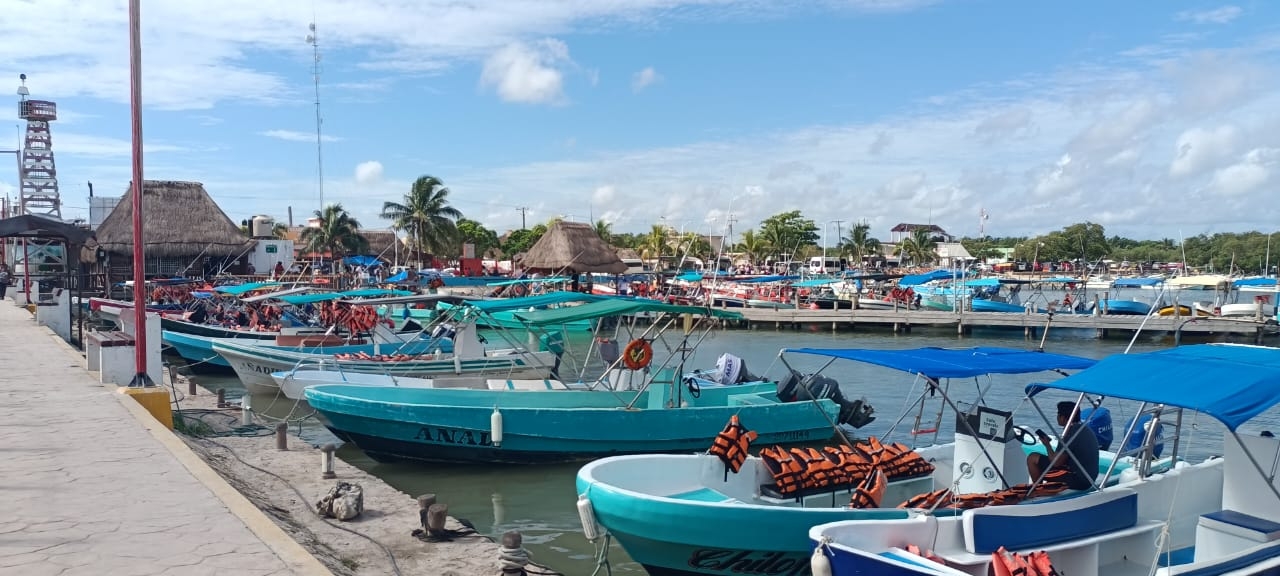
[480,38,572,104]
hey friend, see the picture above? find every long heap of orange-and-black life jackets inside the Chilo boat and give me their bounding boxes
[760,438,933,497]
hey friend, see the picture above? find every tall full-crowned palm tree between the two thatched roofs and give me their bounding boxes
[381,175,462,256]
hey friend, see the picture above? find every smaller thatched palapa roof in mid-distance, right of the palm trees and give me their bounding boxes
[520,220,627,274]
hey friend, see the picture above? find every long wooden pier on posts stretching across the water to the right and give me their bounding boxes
[733,308,1280,342]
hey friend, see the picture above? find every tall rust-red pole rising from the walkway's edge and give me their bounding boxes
[129,0,155,387]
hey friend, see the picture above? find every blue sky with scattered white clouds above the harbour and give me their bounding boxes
[0,0,1280,244]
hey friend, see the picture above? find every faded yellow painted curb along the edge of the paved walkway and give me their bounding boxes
[41,326,333,576]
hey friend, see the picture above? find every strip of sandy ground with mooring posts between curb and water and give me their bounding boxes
[174,376,519,576]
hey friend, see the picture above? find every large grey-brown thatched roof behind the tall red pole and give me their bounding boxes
[97,180,253,257]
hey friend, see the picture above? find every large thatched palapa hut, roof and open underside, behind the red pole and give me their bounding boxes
[97,180,253,278]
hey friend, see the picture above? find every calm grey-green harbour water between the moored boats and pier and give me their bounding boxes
[183,321,1280,576]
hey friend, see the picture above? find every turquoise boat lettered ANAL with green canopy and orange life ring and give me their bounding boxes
[303,298,865,463]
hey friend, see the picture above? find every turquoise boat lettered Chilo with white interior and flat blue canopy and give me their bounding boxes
[577,347,1094,576]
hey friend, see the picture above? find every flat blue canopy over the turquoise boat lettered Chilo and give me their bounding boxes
[782,346,1097,378]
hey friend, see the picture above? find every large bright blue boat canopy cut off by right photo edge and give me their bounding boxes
[1027,344,1280,431]
